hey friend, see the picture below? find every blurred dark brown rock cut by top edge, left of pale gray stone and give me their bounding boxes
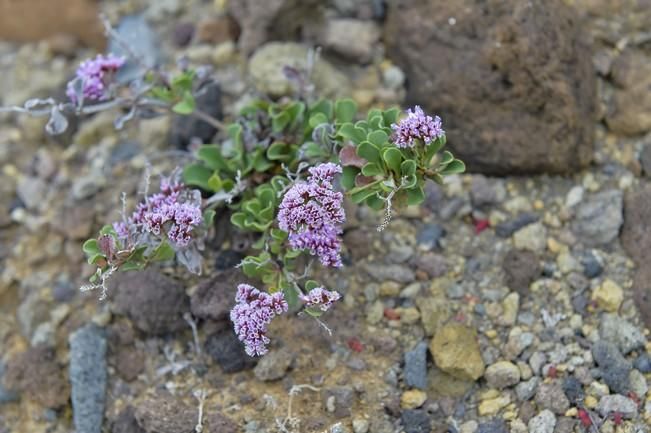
[228,0,322,55]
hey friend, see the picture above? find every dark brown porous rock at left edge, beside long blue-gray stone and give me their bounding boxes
[3,346,70,409]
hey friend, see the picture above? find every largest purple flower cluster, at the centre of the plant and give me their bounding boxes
[278,162,346,267]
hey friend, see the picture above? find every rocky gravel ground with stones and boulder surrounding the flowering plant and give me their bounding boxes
[0,0,651,433]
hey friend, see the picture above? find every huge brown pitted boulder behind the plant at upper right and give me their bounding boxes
[384,0,596,174]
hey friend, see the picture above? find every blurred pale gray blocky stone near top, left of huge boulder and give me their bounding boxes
[322,18,380,63]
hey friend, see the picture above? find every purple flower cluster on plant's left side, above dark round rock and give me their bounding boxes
[113,179,203,247]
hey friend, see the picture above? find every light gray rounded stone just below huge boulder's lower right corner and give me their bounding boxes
[572,190,624,246]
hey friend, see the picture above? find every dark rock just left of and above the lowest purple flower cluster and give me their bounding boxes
[190,269,241,321]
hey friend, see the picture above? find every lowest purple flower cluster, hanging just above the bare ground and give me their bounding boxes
[231,284,288,356]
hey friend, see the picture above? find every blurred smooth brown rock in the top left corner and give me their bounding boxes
[0,0,106,50]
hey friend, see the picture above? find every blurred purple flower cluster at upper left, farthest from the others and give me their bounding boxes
[66,54,124,103]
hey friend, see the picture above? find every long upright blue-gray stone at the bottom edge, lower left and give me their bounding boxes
[69,324,107,433]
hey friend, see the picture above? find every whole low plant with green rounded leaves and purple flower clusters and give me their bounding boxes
[5,21,465,356]
